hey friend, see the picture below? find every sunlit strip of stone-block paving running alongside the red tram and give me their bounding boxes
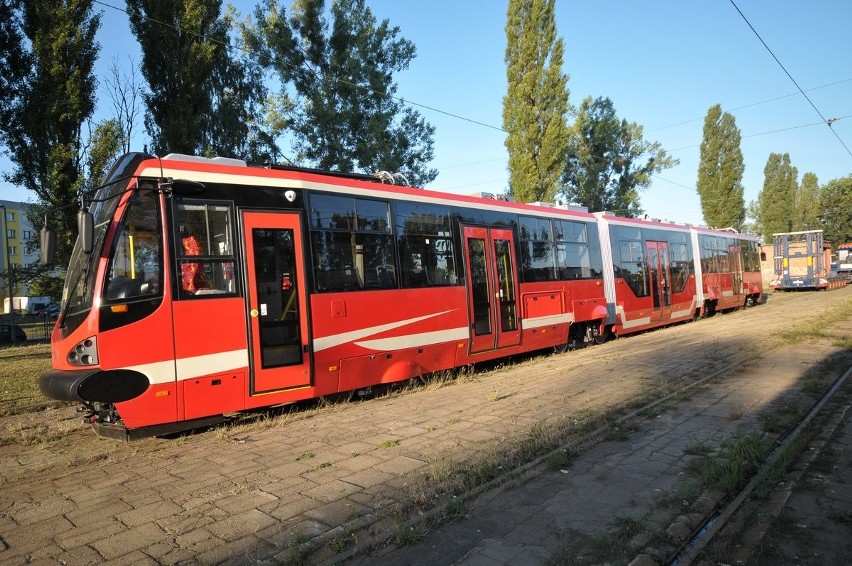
[0,288,852,564]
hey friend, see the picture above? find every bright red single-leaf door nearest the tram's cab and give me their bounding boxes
[243,212,311,394]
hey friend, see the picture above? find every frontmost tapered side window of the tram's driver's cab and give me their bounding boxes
[104,191,163,302]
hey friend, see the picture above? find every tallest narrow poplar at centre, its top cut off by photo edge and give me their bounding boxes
[503,0,569,202]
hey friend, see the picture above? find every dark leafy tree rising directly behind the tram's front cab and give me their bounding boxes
[127,0,274,160]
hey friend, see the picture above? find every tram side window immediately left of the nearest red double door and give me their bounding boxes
[394,202,458,289]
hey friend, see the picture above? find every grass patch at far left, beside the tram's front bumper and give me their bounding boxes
[0,343,51,416]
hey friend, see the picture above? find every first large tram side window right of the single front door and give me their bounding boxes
[310,194,397,292]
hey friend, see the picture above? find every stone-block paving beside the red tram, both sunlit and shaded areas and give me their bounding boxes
[0,288,852,564]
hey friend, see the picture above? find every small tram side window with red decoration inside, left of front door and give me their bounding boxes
[175,202,237,298]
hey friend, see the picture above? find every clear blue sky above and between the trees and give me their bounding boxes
[0,0,852,231]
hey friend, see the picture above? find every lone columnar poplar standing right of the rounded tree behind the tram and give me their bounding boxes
[696,104,745,229]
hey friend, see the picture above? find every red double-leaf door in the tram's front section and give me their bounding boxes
[464,226,521,352]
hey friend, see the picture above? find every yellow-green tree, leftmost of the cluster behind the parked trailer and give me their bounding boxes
[757,153,799,242]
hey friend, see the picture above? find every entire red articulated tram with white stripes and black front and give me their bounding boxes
[40,154,762,438]
